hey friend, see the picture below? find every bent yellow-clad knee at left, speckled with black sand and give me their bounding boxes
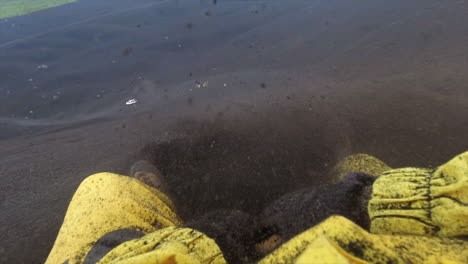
[46,173,182,264]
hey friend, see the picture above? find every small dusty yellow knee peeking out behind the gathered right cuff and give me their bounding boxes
[328,153,391,183]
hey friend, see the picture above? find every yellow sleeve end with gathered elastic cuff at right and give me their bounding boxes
[368,152,468,237]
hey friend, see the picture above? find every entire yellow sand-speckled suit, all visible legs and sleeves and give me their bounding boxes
[47,152,468,264]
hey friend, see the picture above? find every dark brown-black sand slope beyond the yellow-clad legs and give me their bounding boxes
[0,0,468,263]
